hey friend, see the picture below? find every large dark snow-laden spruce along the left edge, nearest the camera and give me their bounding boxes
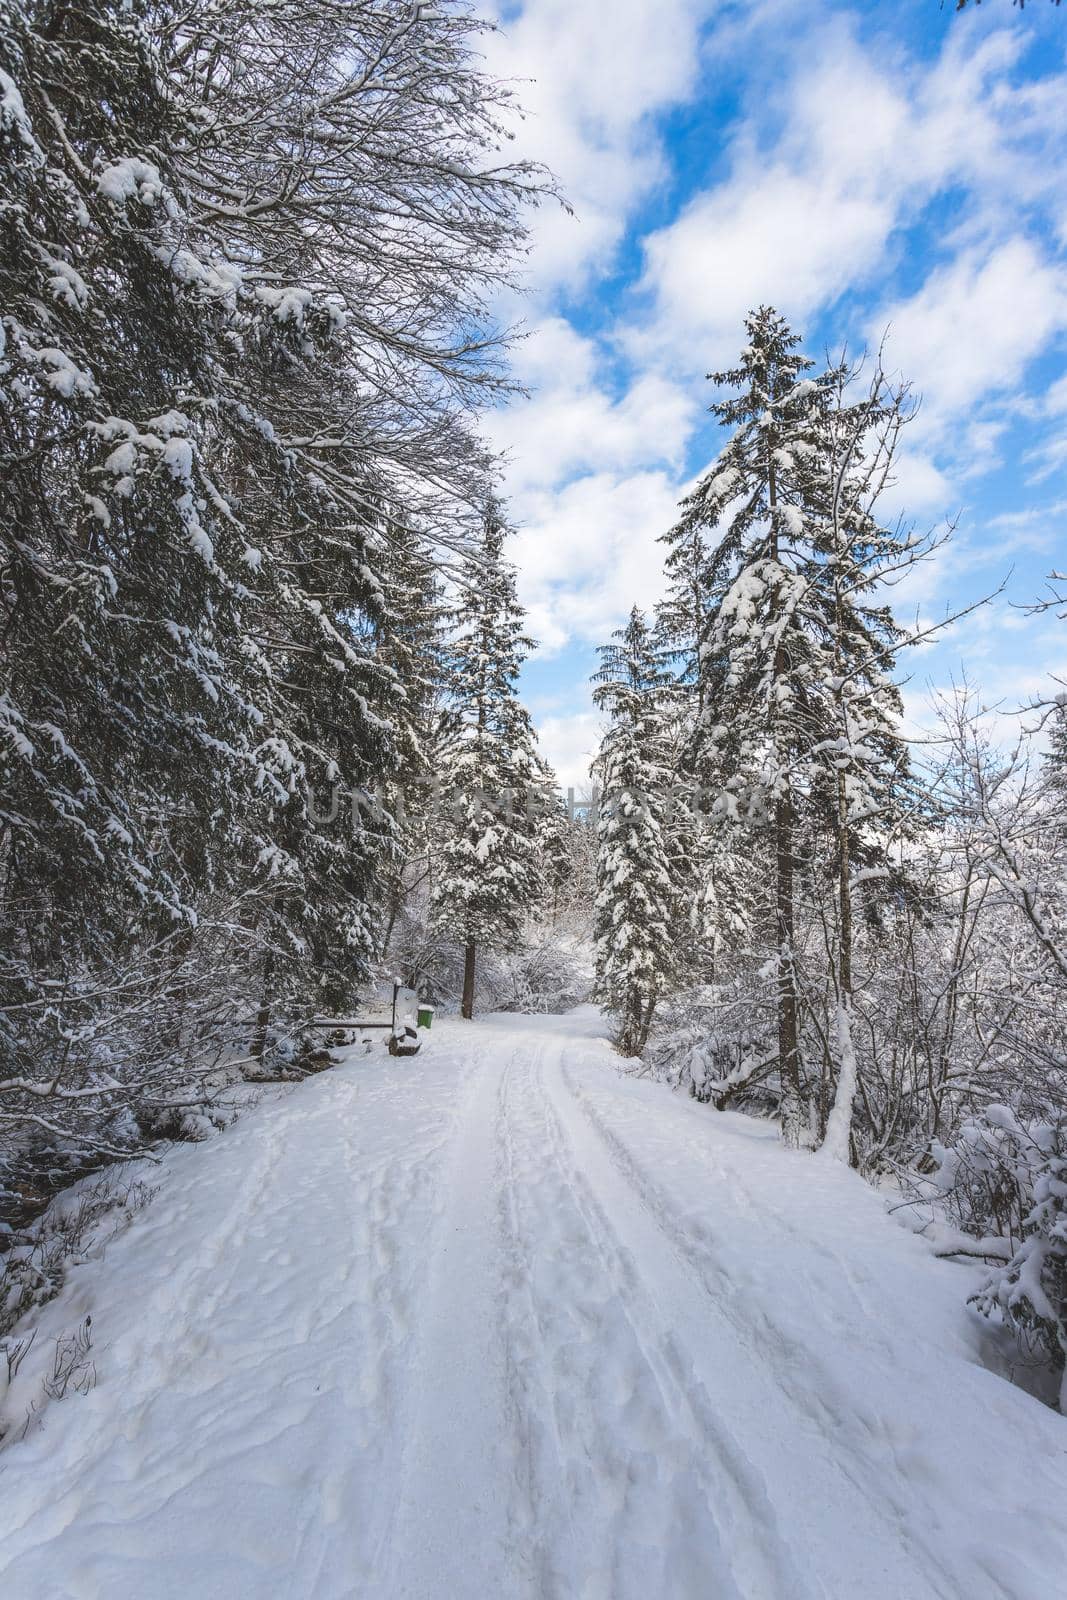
[0,3,275,1138]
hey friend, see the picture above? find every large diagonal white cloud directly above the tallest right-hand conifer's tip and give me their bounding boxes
[627,26,1067,366]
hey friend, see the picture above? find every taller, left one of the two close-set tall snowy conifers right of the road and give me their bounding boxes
[667,307,817,1141]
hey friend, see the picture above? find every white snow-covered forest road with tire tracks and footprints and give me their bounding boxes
[0,1010,1067,1600]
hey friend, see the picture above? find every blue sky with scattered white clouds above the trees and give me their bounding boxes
[476,0,1067,784]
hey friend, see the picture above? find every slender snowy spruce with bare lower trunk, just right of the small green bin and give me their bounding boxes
[432,499,541,1019]
